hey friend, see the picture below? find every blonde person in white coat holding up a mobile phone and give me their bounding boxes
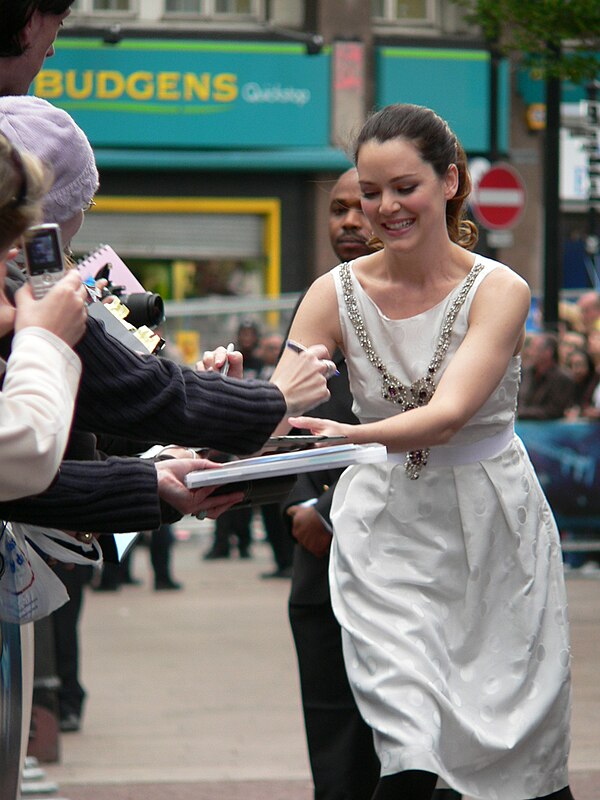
[0,131,87,500]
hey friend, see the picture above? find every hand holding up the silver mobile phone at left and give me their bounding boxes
[15,270,87,347]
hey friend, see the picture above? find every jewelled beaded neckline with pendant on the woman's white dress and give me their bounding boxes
[340,262,483,480]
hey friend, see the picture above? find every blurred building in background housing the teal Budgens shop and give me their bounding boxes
[32,0,592,360]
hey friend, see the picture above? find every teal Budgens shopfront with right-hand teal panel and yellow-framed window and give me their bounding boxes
[32,32,510,299]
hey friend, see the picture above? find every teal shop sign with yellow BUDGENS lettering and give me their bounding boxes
[32,38,329,149]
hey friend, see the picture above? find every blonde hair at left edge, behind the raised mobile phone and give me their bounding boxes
[0,134,51,253]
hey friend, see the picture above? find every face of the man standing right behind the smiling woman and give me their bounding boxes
[329,169,371,261]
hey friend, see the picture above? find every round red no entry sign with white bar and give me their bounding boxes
[471,163,525,230]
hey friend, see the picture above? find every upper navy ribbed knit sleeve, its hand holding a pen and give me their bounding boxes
[74,318,286,454]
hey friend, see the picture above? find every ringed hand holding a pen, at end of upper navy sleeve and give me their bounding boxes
[271,344,332,415]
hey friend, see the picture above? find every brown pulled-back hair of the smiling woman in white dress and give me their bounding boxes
[354,103,478,250]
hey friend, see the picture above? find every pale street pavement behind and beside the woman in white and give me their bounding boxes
[27,521,600,800]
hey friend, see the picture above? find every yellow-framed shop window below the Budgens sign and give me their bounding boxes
[72,197,281,300]
